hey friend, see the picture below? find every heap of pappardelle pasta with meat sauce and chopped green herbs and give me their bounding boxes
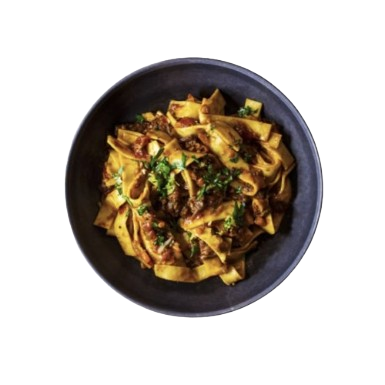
[94,90,295,285]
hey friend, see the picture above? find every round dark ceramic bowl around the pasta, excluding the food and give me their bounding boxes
[65,58,323,317]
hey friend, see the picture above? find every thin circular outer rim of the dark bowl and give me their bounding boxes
[64,56,325,318]
